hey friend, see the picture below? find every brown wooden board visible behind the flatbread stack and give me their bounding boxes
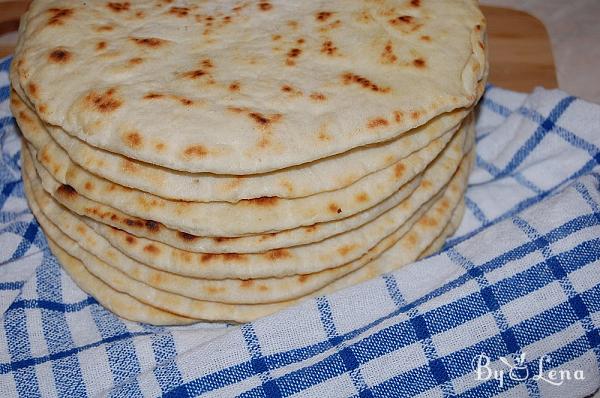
[0,0,558,91]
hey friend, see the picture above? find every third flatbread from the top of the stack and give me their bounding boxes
[23,120,467,237]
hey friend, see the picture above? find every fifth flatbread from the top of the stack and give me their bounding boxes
[23,141,468,282]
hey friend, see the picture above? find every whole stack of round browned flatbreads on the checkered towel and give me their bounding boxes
[11,0,487,324]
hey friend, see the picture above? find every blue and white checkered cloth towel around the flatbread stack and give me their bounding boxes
[0,55,600,397]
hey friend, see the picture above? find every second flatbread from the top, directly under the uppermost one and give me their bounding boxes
[11,85,470,202]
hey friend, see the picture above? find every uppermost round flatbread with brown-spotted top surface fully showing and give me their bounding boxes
[15,0,485,174]
